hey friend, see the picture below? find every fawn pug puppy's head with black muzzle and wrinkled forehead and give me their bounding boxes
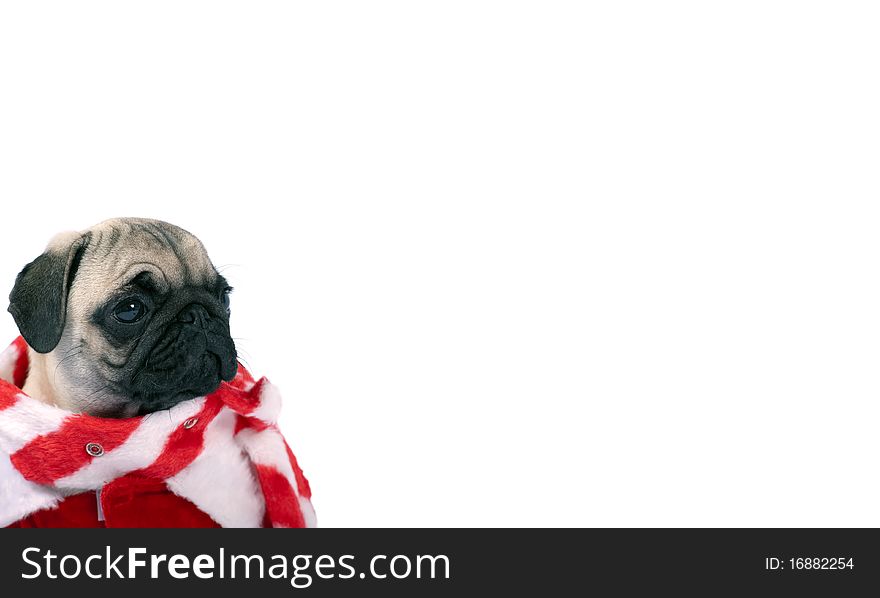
[9,218,238,417]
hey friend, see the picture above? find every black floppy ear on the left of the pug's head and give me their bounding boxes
[9,235,89,353]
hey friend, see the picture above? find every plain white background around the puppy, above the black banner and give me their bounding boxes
[0,0,880,526]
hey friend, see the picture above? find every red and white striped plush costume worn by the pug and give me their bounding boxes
[0,337,315,527]
